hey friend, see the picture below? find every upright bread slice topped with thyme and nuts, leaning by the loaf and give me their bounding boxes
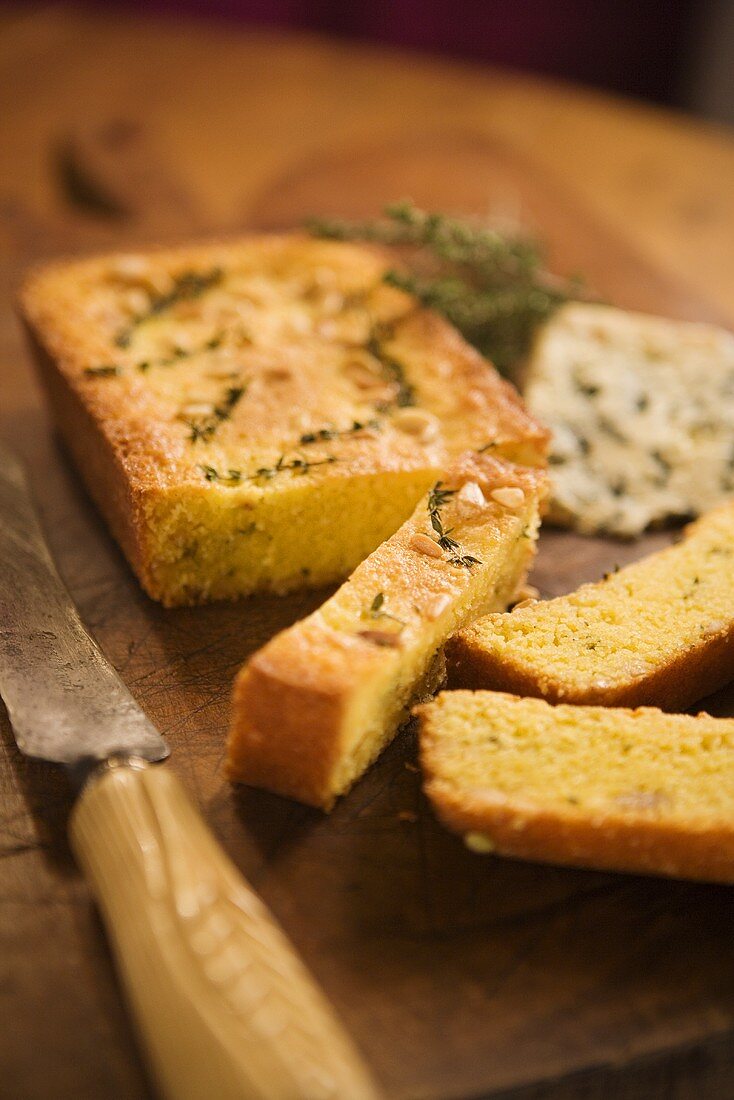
[228,454,545,810]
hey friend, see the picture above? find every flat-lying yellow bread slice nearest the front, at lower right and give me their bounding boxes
[418,691,734,882]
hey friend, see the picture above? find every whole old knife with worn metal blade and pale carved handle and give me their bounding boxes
[0,447,380,1100]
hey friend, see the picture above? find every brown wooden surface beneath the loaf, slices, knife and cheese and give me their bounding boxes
[0,7,734,1100]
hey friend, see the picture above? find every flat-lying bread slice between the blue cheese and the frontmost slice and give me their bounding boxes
[447,503,734,711]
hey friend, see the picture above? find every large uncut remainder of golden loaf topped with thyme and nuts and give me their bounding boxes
[21,235,548,605]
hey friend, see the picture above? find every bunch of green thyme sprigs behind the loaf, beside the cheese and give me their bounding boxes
[306,202,581,374]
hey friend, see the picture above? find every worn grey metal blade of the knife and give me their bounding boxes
[0,444,168,765]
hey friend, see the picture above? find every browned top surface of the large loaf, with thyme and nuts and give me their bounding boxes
[21,234,547,495]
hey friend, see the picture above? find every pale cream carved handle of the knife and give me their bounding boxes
[70,765,380,1100]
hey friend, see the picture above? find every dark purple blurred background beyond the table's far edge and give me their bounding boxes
[10,0,734,123]
